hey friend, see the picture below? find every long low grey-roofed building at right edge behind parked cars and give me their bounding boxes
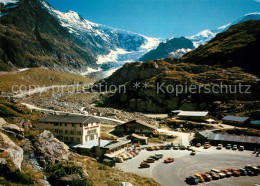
[196,130,260,150]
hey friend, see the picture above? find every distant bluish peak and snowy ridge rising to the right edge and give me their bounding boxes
[140,12,260,61]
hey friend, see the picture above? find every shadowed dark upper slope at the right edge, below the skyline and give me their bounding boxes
[182,20,260,76]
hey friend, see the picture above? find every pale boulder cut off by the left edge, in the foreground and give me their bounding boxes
[0,132,23,172]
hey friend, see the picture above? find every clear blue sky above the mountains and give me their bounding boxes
[47,0,260,38]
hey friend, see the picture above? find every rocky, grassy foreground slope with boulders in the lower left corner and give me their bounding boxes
[0,98,159,186]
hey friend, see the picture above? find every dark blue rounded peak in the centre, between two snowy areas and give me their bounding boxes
[139,37,194,61]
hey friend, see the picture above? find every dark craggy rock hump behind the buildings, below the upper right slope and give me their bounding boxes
[103,59,260,113]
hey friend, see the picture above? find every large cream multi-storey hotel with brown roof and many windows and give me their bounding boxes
[38,115,100,144]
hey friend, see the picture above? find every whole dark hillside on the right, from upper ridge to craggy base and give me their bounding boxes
[97,21,260,113]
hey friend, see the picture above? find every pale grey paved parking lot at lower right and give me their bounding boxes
[116,147,260,186]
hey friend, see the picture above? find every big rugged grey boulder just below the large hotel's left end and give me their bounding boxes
[32,130,70,167]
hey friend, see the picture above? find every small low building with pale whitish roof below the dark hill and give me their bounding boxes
[177,111,208,121]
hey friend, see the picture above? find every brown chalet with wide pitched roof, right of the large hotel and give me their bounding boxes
[115,119,157,136]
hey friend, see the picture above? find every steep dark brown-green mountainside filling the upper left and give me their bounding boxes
[0,0,96,72]
